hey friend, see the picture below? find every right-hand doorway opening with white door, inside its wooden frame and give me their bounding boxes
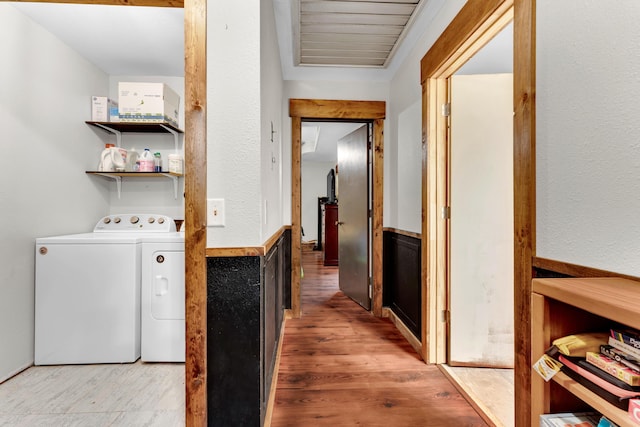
[446,24,514,426]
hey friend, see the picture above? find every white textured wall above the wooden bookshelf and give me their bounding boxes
[536,0,640,276]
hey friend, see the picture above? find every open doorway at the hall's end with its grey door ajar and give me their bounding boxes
[301,121,372,310]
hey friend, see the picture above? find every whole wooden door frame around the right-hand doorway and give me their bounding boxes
[421,0,535,426]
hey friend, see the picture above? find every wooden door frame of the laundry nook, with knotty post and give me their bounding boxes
[8,0,207,427]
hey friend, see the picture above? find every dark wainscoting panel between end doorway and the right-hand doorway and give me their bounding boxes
[383,230,422,339]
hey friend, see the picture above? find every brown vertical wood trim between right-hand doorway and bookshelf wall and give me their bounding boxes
[513,0,536,426]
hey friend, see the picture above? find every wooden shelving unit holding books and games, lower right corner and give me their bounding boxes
[531,278,640,427]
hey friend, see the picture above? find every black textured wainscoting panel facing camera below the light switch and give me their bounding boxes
[207,257,262,427]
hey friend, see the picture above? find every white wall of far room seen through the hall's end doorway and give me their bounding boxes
[301,159,336,242]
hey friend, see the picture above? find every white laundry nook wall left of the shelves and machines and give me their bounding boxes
[0,3,109,381]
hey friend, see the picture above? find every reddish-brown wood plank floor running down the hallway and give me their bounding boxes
[271,252,487,427]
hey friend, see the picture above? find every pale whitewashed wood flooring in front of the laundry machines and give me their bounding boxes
[0,361,185,427]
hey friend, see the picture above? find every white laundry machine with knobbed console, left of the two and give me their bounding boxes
[35,214,175,365]
